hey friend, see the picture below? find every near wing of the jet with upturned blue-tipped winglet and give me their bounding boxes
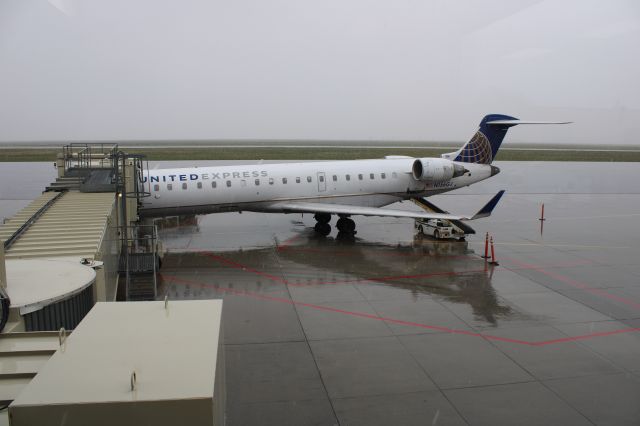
[265,190,504,220]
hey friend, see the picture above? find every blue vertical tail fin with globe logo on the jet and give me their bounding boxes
[444,114,518,164]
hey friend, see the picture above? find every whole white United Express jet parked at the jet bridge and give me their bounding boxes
[140,114,565,235]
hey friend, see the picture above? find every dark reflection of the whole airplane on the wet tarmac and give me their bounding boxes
[161,217,515,324]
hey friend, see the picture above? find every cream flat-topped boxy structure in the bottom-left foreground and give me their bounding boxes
[10,300,224,425]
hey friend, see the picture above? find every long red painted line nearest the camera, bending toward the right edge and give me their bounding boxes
[162,274,640,346]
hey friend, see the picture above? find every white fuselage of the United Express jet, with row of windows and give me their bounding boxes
[140,158,491,216]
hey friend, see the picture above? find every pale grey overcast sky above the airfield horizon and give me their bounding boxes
[0,0,640,144]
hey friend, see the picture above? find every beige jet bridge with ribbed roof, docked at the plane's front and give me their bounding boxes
[0,144,159,331]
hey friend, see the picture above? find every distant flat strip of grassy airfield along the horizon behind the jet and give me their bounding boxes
[0,140,640,162]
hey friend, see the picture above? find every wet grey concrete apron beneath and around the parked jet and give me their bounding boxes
[1,163,640,425]
